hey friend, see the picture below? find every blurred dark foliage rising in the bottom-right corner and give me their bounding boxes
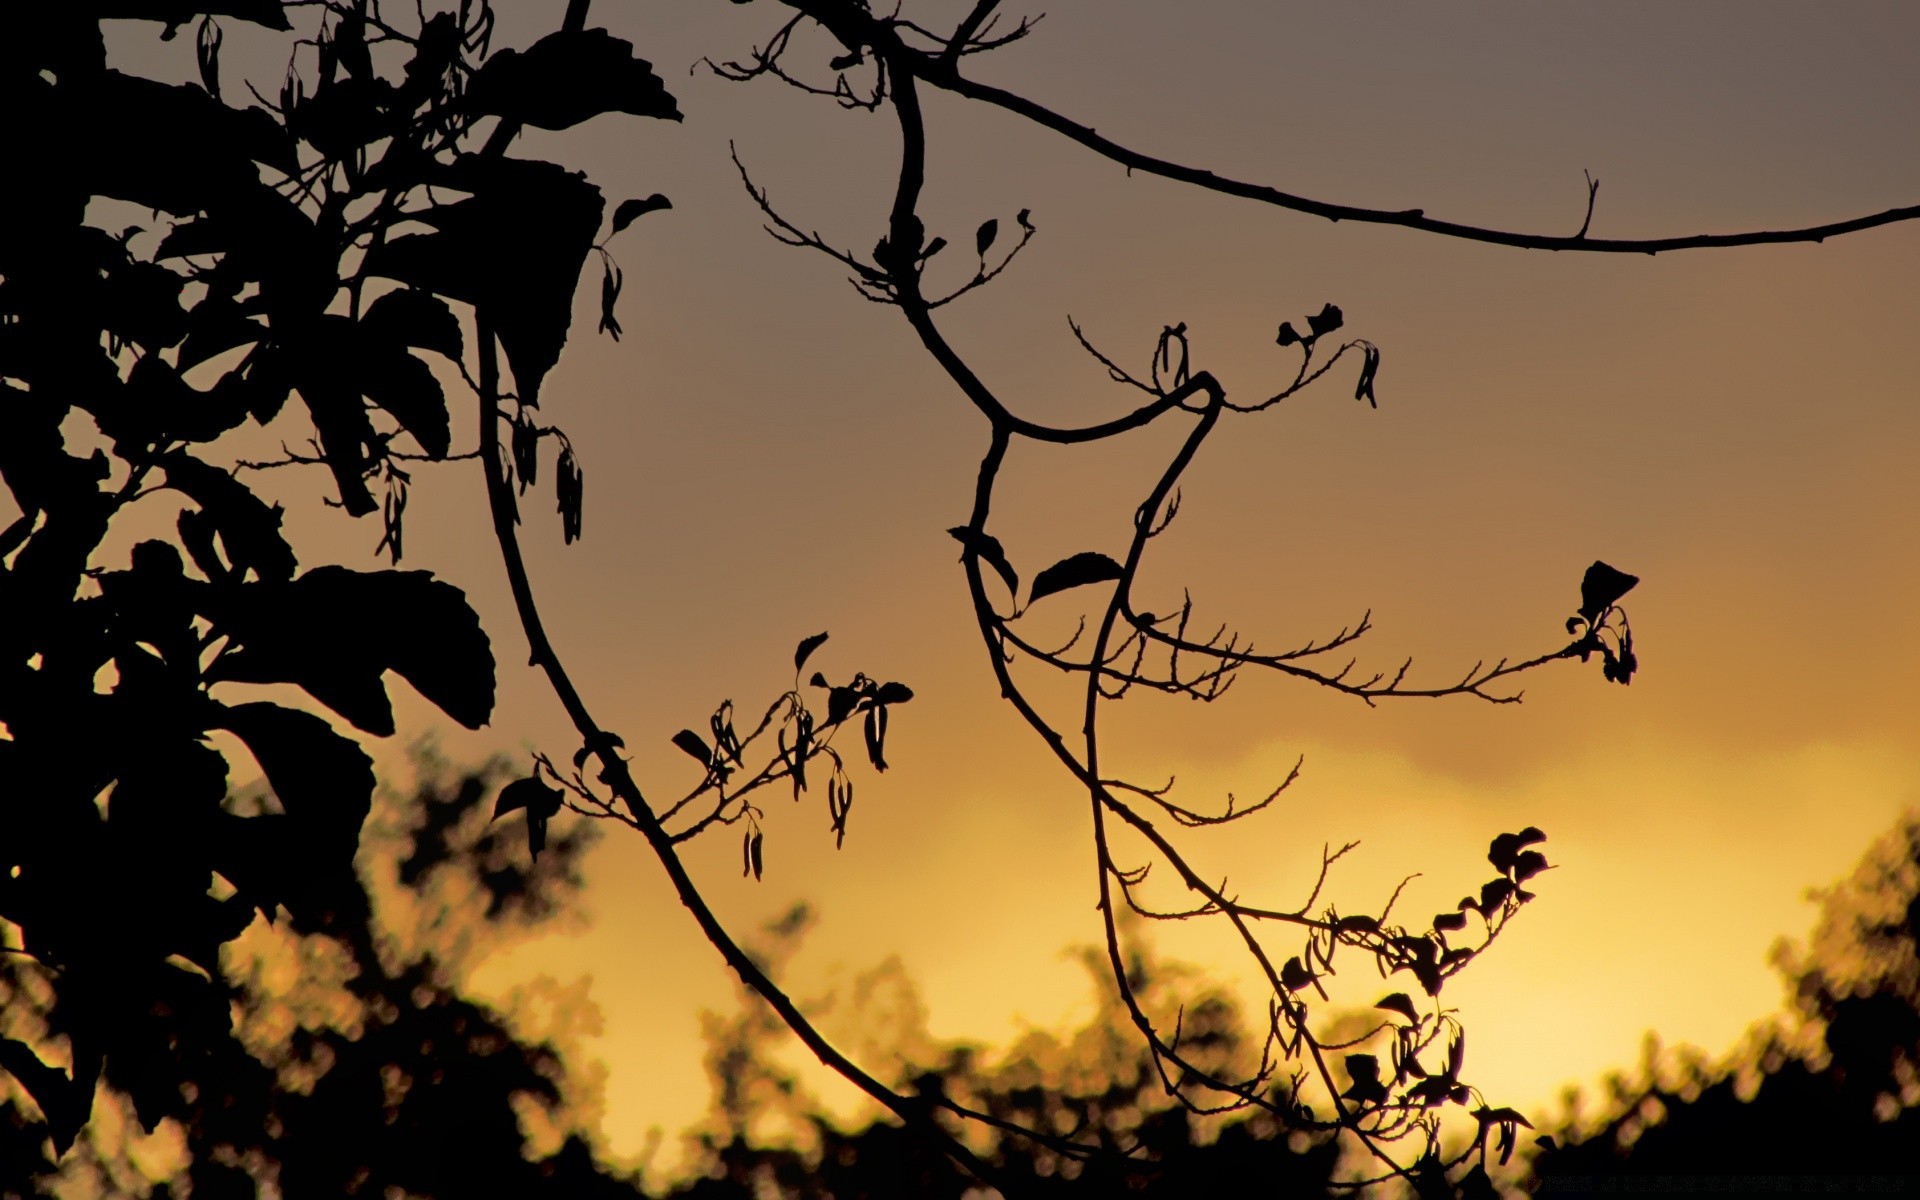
[1532,812,1920,1194]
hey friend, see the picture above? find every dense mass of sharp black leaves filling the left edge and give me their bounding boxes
[0,0,678,1150]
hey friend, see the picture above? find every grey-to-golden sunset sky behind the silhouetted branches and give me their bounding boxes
[116,0,1920,1182]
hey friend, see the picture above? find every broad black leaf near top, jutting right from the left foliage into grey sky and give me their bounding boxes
[467,29,680,129]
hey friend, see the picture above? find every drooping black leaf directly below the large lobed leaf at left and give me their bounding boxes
[207,703,374,858]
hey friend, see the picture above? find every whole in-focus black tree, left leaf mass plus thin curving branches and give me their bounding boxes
[0,0,1920,1194]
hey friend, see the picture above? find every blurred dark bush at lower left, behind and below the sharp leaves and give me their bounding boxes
[0,756,639,1200]
